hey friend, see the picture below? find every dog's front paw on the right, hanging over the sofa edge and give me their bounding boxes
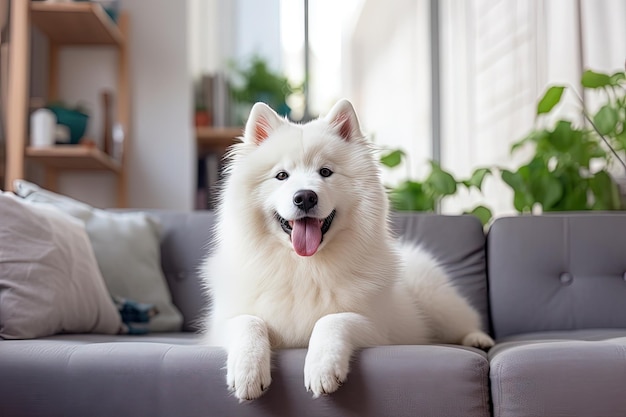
[304,350,350,398]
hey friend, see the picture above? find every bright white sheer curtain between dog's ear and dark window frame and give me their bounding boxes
[343,0,432,184]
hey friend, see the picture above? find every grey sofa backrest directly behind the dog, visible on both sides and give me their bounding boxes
[151,211,489,331]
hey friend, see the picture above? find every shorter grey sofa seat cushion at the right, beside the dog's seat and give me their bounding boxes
[489,329,626,417]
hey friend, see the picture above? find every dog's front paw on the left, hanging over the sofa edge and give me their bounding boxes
[226,344,272,402]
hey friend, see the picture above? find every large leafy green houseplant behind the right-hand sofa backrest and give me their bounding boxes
[500,70,626,213]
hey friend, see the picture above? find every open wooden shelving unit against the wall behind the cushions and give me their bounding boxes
[5,0,130,207]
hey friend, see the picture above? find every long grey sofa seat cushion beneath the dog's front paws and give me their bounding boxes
[0,342,490,417]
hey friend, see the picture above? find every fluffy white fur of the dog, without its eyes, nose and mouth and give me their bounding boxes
[203,100,493,400]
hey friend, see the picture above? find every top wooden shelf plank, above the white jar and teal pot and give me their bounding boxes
[30,2,124,46]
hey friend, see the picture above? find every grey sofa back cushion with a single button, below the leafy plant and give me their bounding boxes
[487,212,626,338]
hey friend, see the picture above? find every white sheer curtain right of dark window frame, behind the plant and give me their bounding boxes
[440,0,626,214]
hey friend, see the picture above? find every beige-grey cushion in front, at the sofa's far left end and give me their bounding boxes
[0,193,122,339]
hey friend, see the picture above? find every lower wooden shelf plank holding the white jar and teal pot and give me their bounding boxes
[26,145,120,173]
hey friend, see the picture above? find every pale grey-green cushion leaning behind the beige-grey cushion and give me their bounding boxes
[15,180,182,331]
